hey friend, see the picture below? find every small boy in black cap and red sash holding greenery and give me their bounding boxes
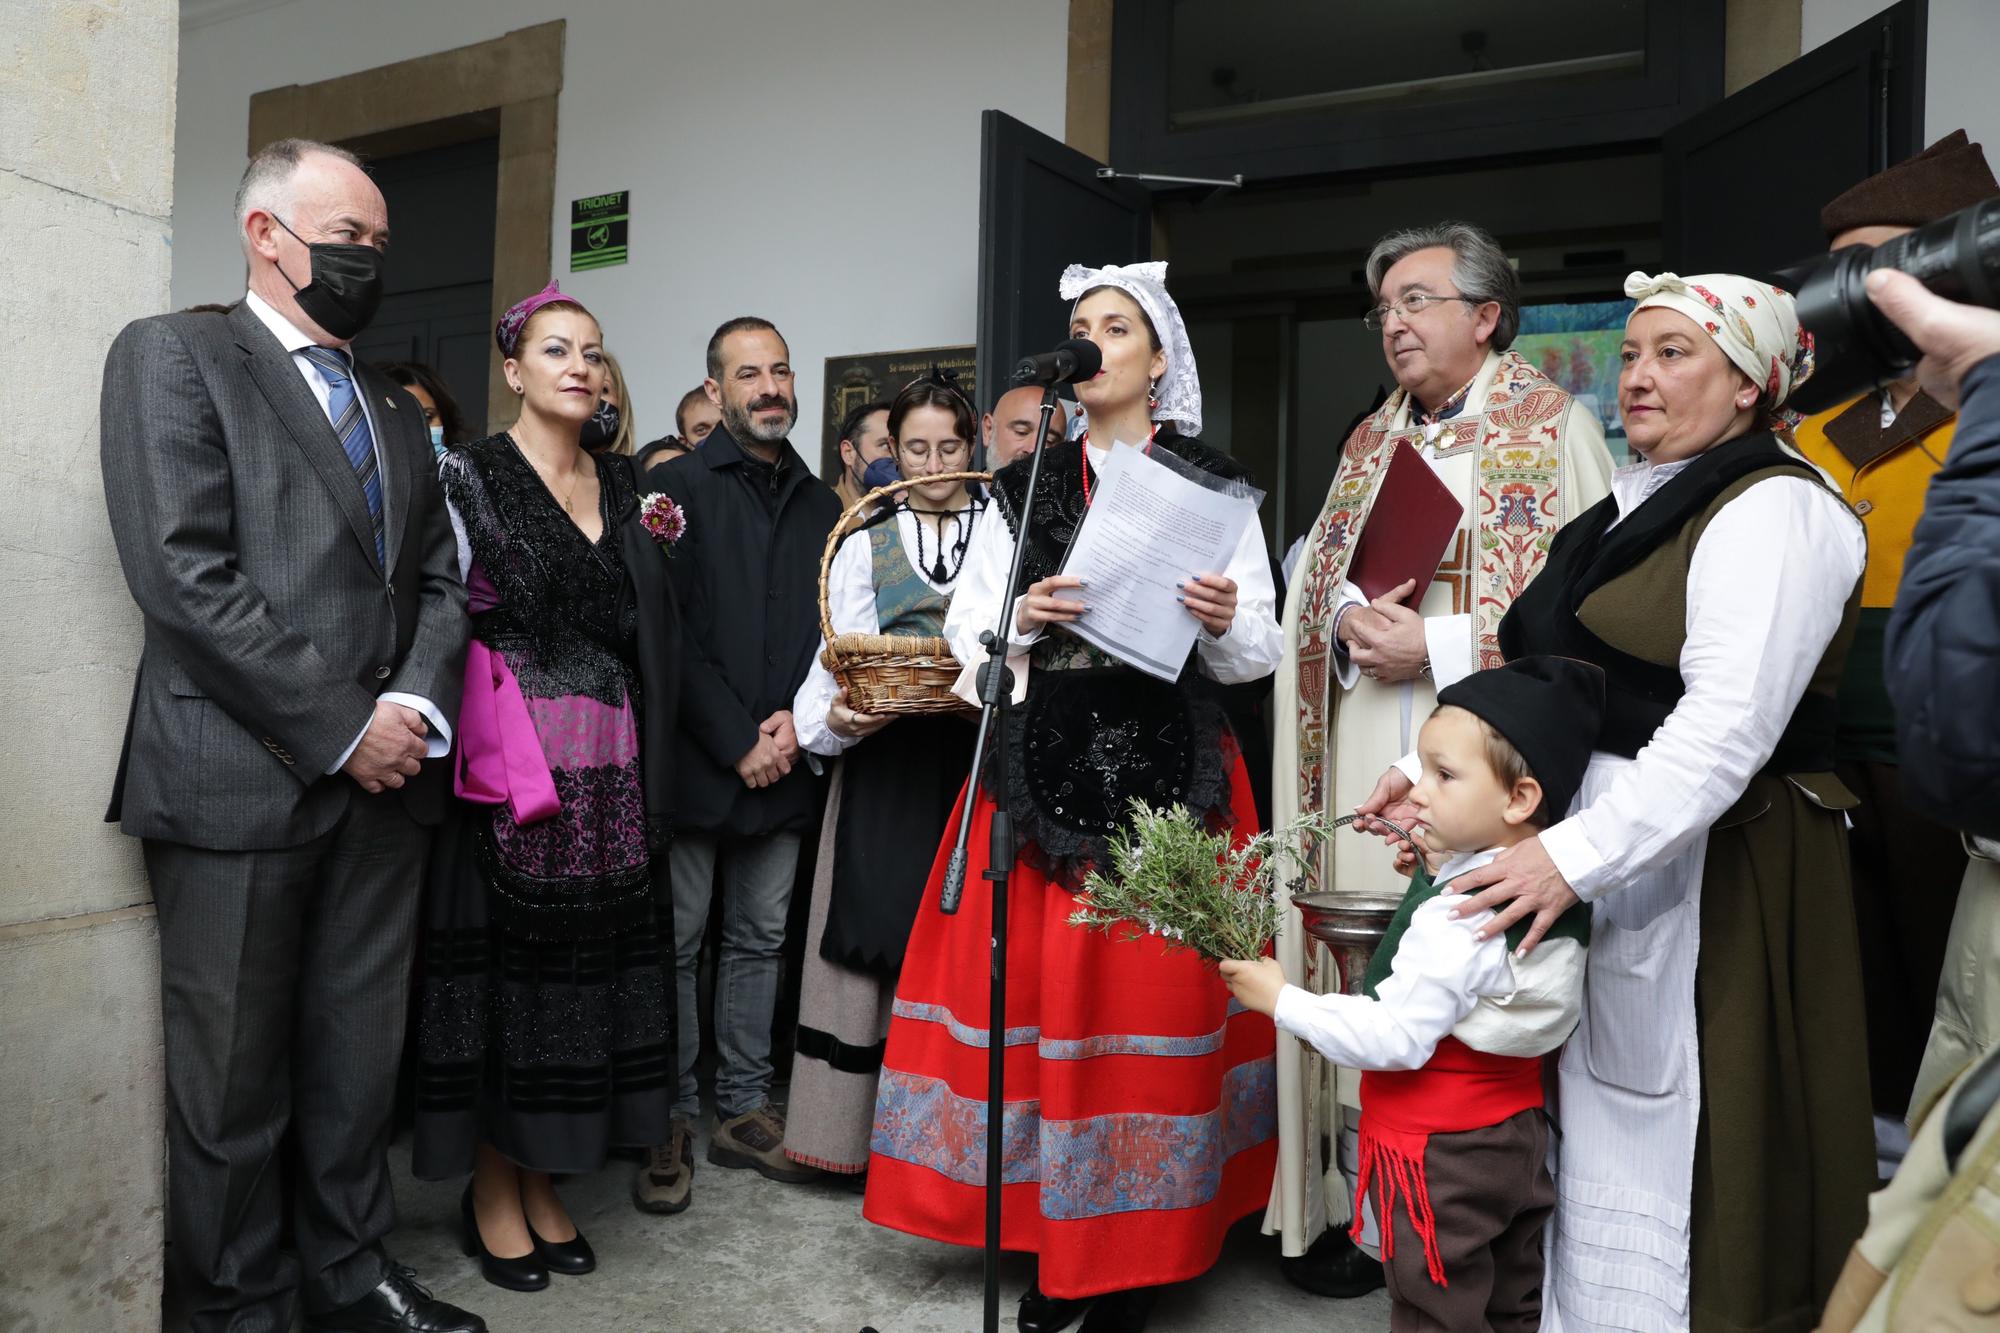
[1222,656,1604,1333]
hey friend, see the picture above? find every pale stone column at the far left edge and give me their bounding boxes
[0,0,180,1329]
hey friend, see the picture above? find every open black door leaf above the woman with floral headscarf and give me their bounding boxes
[1660,0,1926,276]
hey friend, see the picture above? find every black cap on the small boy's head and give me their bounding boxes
[1438,656,1604,819]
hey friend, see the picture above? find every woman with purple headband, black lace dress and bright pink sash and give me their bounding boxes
[414,284,674,1291]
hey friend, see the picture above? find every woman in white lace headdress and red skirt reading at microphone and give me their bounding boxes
[866,264,1282,1333]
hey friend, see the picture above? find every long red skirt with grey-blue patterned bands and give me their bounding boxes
[862,747,1278,1299]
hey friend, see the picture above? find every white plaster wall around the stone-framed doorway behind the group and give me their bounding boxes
[174,0,1068,462]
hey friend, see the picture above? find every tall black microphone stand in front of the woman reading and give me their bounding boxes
[938,374,1064,1333]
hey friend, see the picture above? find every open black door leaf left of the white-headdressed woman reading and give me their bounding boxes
[978,110,1152,430]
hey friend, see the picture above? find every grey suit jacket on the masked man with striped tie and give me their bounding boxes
[102,304,468,851]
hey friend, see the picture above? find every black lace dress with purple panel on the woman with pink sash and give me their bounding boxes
[414,434,674,1179]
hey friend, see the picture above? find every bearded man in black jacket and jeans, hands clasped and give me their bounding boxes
[632,316,840,1213]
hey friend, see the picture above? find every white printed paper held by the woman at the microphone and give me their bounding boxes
[1058,448,1256,681]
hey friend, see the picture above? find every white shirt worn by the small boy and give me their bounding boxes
[1276,849,1584,1069]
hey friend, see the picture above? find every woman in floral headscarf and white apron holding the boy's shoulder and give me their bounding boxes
[1352,272,1874,1333]
